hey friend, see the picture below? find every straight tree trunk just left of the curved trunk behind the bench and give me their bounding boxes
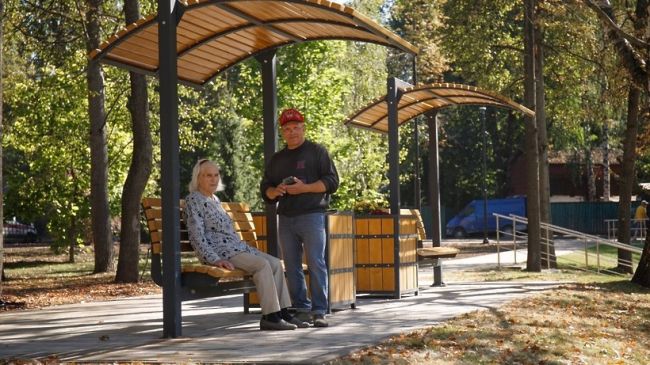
[86,0,114,273]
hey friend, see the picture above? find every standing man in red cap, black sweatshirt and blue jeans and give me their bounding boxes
[260,108,339,327]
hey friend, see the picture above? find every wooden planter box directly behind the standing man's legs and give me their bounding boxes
[244,212,357,312]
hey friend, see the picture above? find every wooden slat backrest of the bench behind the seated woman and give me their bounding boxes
[142,198,257,254]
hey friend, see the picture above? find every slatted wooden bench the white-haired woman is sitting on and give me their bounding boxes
[142,198,257,313]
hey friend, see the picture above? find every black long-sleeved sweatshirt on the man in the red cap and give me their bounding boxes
[260,140,339,217]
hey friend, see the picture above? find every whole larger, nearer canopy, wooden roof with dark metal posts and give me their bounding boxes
[89,0,418,338]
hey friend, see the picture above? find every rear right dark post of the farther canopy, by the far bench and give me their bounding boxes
[426,111,445,286]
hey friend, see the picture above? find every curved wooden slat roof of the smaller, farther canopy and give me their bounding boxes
[345,83,535,133]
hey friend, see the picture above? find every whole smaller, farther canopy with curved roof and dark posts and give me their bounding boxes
[352,77,535,284]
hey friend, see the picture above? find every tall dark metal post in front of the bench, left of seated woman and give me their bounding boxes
[158,0,182,338]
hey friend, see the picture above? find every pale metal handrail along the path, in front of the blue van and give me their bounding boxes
[493,213,643,272]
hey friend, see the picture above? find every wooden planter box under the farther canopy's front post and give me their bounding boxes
[354,215,418,299]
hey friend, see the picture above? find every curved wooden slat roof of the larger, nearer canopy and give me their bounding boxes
[89,0,418,86]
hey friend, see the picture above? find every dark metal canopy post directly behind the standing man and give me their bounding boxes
[255,49,279,257]
